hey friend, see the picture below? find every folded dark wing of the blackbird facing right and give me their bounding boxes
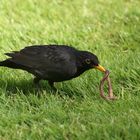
[6,46,76,70]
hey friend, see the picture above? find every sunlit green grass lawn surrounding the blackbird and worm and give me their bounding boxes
[0,0,140,140]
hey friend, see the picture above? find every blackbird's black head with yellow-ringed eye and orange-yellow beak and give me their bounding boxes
[81,51,106,72]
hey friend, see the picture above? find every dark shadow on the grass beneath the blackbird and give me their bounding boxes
[0,78,83,99]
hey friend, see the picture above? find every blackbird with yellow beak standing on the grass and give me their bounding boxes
[0,45,105,88]
